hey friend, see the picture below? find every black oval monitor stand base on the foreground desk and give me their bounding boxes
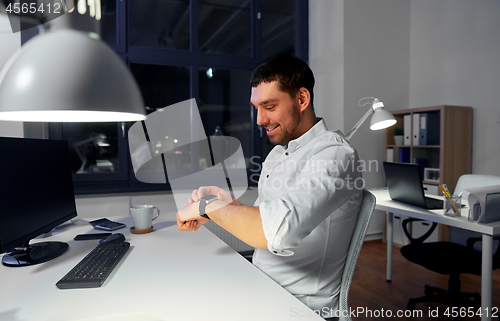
[2,242,69,267]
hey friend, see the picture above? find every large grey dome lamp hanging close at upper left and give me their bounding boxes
[0,0,146,122]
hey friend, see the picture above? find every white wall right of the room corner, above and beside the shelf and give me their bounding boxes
[409,0,500,176]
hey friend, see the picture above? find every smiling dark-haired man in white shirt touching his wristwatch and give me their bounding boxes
[177,54,362,317]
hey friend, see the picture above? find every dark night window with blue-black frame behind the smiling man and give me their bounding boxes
[35,0,308,194]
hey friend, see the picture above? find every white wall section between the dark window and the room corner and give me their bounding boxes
[309,0,410,239]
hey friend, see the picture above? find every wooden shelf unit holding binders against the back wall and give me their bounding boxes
[385,105,472,240]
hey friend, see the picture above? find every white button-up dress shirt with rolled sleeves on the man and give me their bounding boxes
[253,119,364,311]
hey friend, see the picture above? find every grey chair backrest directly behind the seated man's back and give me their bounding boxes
[339,189,375,320]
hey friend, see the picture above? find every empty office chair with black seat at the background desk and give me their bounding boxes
[401,174,500,310]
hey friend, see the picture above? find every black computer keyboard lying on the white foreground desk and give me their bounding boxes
[56,242,130,289]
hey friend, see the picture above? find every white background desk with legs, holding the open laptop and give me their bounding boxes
[370,188,500,320]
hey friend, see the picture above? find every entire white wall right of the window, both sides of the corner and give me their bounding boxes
[309,0,500,239]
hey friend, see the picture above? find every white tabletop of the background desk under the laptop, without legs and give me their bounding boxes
[370,188,500,235]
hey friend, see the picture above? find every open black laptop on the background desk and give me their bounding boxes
[384,162,443,210]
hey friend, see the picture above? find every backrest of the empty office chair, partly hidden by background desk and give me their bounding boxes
[449,174,500,246]
